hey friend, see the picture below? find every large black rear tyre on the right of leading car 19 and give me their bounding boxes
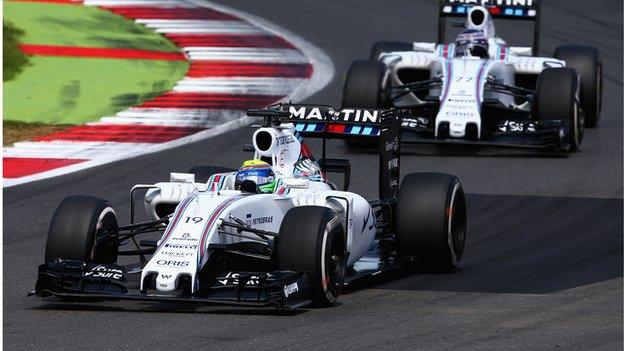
[396,173,467,272]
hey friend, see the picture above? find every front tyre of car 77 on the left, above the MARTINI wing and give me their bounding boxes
[342,60,389,148]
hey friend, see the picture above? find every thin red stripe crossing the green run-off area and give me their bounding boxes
[20,44,186,61]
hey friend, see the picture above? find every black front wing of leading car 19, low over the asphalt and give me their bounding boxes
[29,260,311,309]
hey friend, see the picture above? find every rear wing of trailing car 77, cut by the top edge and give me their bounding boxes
[438,0,541,55]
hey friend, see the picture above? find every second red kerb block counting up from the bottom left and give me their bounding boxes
[35,124,204,143]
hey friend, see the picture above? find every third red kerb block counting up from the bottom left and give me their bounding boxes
[139,92,283,110]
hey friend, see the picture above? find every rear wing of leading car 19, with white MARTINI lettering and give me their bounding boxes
[247,103,404,201]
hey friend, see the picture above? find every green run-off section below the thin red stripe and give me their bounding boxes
[4,56,186,124]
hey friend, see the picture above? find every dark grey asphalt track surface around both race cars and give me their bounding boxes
[3,0,623,350]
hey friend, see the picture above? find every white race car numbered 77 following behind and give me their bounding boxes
[342,0,602,151]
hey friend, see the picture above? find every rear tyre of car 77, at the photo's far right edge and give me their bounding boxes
[554,45,602,128]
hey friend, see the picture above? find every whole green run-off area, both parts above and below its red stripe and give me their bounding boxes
[3,1,188,124]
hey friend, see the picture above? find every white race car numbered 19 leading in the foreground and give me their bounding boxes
[32,104,466,309]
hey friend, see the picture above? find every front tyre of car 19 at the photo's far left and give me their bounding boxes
[45,196,119,263]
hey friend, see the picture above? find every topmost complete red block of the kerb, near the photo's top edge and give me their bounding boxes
[100,6,238,20]
